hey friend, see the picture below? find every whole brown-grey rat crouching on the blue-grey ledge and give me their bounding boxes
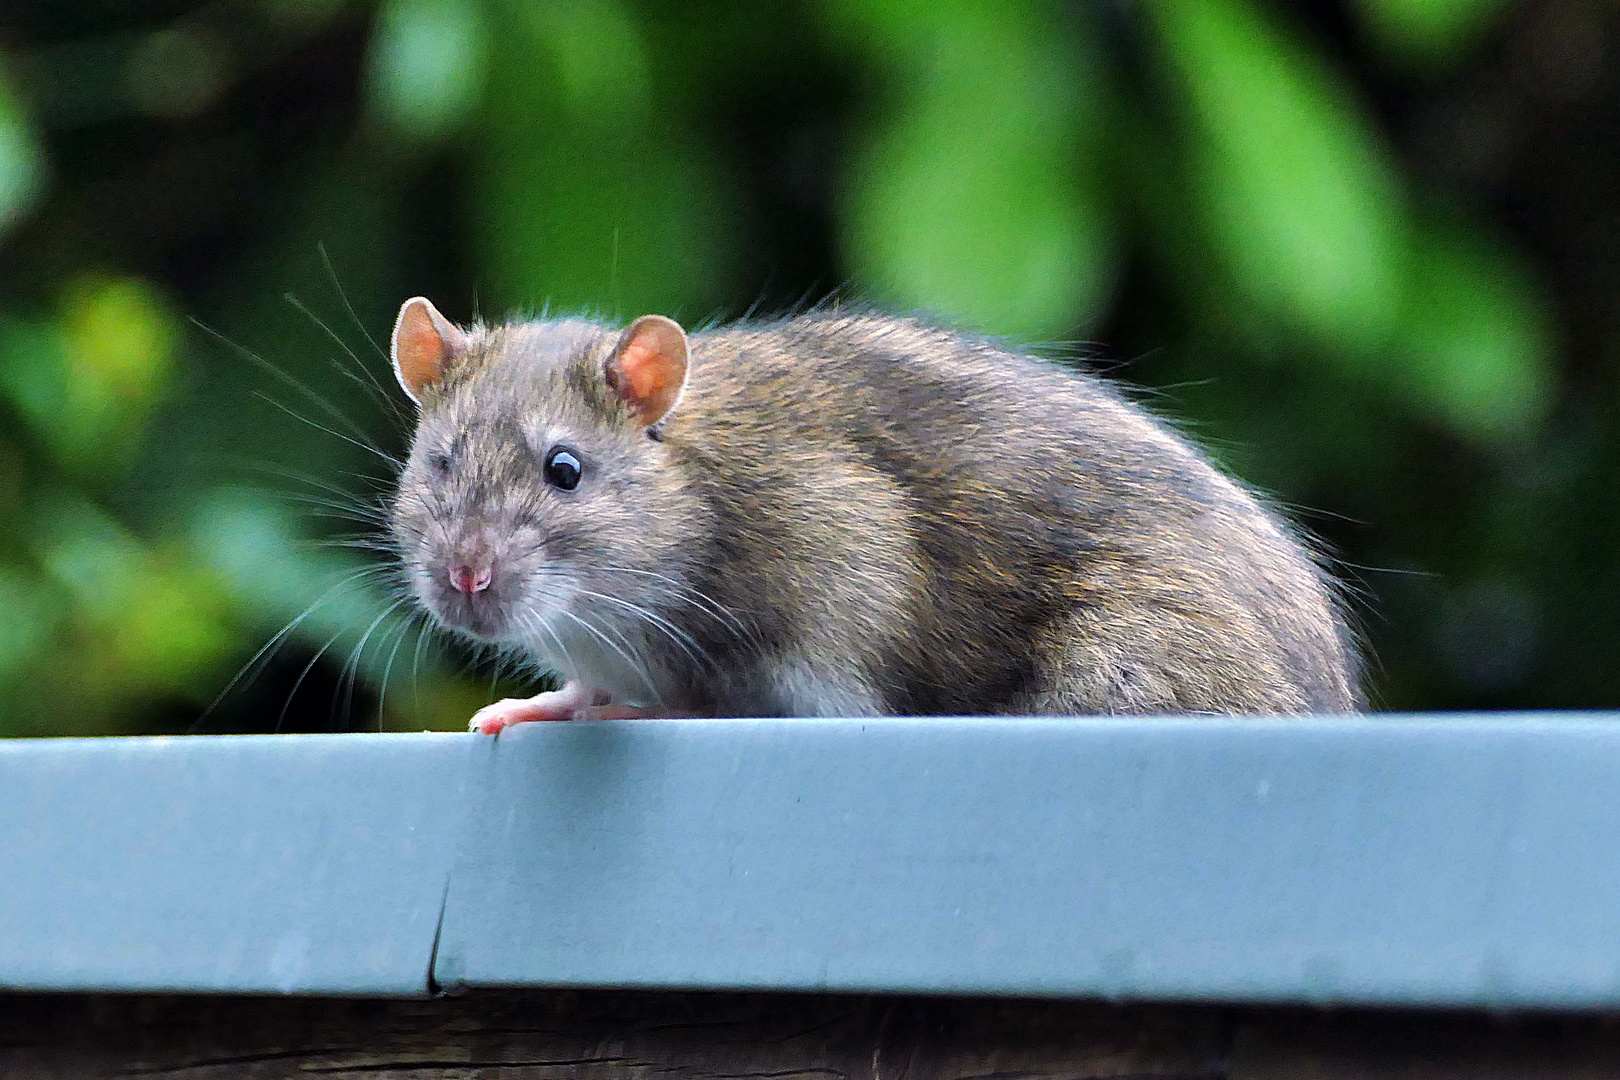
[390,296,1362,733]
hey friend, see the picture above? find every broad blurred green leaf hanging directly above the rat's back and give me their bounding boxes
[834,0,1115,338]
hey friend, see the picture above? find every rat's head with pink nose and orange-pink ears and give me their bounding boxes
[392,298,695,661]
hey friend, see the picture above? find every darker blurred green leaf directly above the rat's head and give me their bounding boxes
[473,0,737,321]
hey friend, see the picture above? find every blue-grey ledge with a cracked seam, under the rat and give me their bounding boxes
[0,714,1620,1009]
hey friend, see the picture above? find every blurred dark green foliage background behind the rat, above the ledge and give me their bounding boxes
[0,0,1620,735]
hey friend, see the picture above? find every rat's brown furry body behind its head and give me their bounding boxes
[666,313,1359,714]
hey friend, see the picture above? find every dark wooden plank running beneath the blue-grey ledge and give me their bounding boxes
[0,991,1620,1080]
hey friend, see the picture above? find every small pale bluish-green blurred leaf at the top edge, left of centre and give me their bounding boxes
[368,0,489,139]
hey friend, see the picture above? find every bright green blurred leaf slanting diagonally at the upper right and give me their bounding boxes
[1147,0,1406,351]
